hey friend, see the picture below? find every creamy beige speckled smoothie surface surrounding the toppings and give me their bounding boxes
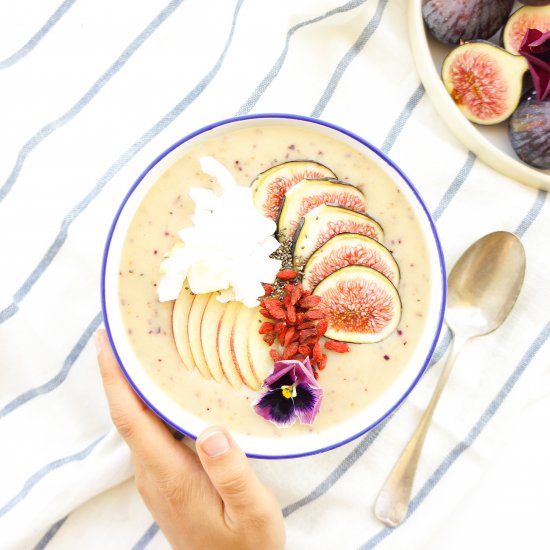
[119,122,432,437]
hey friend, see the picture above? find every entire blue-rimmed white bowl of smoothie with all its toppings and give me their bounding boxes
[102,114,445,458]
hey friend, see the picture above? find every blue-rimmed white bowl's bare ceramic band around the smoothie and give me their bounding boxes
[101,114,446,458]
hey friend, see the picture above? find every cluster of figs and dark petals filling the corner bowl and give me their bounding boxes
[422,0,550,169]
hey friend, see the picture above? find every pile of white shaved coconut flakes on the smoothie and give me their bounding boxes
[157,157,281,307]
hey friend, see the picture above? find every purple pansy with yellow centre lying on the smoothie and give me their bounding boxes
[252,357,323,428]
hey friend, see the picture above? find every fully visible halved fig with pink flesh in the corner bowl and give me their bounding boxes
[441,41,528,125]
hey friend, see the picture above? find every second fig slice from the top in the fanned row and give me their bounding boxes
[277,179,367,242]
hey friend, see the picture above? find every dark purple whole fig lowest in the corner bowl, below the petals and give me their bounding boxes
[508,92,550,168]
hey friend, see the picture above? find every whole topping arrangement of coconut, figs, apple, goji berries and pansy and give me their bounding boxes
[158,157,401,426]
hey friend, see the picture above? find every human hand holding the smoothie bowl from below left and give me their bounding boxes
[95,330,285,550]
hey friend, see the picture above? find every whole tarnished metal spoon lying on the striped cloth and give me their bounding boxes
[374,231,525,527]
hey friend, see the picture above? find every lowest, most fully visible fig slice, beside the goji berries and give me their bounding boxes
[313,265,401,344]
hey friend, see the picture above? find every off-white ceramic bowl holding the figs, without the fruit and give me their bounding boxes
[409,0,550,191]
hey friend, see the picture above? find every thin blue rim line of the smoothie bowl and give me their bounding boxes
[101,113,447,460]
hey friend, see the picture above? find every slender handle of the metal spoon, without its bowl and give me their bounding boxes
[374,336,466,527]
